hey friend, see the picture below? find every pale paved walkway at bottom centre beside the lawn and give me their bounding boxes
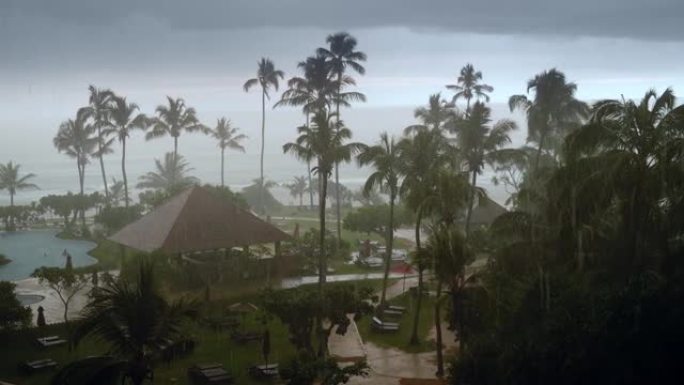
[328,277,456,385]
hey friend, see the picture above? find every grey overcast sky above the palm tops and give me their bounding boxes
[0,0,684,158]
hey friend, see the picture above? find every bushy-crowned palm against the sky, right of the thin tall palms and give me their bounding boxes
[508,68,589,172]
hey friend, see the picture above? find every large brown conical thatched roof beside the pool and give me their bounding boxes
[109,186,290,253]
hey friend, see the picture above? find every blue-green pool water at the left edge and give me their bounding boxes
[0,230,96,281]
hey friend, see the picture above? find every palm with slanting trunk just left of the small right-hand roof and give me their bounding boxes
[455,101,517,240]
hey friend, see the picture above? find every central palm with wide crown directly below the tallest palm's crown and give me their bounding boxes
[283,110,364,291]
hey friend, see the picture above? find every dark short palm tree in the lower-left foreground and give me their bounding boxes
[73,261,197,385]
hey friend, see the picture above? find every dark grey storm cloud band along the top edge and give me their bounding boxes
[0,0,684,40]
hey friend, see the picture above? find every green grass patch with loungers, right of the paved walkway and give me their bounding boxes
[357,293,435,353]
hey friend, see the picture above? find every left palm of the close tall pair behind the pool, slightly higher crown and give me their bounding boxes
[86,85,114,198]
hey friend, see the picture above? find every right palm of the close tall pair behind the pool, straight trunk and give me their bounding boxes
[109,96,148,207]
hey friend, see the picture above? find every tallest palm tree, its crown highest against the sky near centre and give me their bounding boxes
[316,32,366,243]
